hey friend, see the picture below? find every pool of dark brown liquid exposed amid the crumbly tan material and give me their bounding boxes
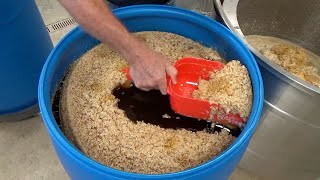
[112,83,241,136]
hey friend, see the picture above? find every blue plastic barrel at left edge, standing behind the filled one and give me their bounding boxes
[0,0,53,121]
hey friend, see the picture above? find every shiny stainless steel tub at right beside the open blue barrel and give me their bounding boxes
[214,0,320,179]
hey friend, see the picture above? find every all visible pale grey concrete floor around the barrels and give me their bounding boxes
[0,0,260,180]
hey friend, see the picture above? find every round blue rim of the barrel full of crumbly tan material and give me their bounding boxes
[38,5,264,178]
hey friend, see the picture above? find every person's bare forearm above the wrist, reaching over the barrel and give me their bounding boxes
[59,0,143,63]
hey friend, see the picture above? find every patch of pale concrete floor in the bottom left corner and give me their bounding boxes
[0,117,68,180]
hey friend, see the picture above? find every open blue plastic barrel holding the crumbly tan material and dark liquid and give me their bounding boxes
[39,5,264,180]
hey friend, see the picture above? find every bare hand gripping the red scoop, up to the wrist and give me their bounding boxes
[127,45,177,95]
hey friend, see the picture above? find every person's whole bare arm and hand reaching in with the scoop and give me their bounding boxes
[59,0,177,94]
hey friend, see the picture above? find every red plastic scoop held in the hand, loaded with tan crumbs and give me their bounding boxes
[124,58,246,127]
